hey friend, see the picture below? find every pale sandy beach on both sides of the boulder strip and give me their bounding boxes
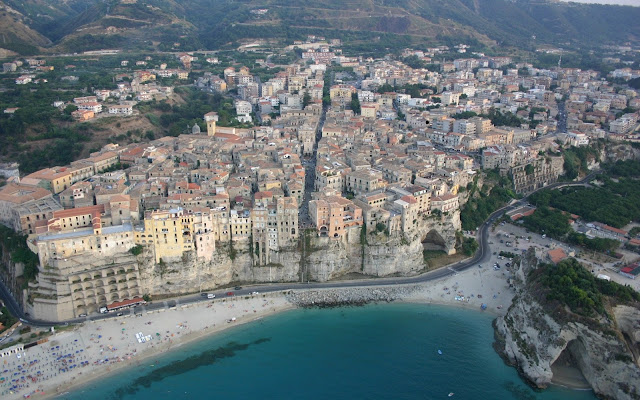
[0,267,513,399]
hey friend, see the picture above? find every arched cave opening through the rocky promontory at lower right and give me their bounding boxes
[551,338,591,389]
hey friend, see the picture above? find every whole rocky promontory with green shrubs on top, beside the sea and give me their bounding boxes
[494,252,640,399]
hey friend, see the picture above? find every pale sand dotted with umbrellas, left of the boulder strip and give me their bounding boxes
[0,293,293,400]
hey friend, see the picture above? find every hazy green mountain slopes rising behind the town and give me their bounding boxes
[0,0,640,51]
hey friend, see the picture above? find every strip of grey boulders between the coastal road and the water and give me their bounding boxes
[287,286,415,308]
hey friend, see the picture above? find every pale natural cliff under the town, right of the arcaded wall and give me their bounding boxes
[132,212,460,295]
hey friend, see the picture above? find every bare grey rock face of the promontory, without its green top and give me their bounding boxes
[494,255,640,399]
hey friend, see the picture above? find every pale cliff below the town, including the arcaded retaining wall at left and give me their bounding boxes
[22,212,460,321]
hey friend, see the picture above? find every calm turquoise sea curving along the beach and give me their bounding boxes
[61,304,595,400]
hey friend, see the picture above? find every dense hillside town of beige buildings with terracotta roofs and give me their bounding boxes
[0,37,640,319]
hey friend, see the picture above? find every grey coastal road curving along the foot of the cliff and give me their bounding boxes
[0,172,596,327]
